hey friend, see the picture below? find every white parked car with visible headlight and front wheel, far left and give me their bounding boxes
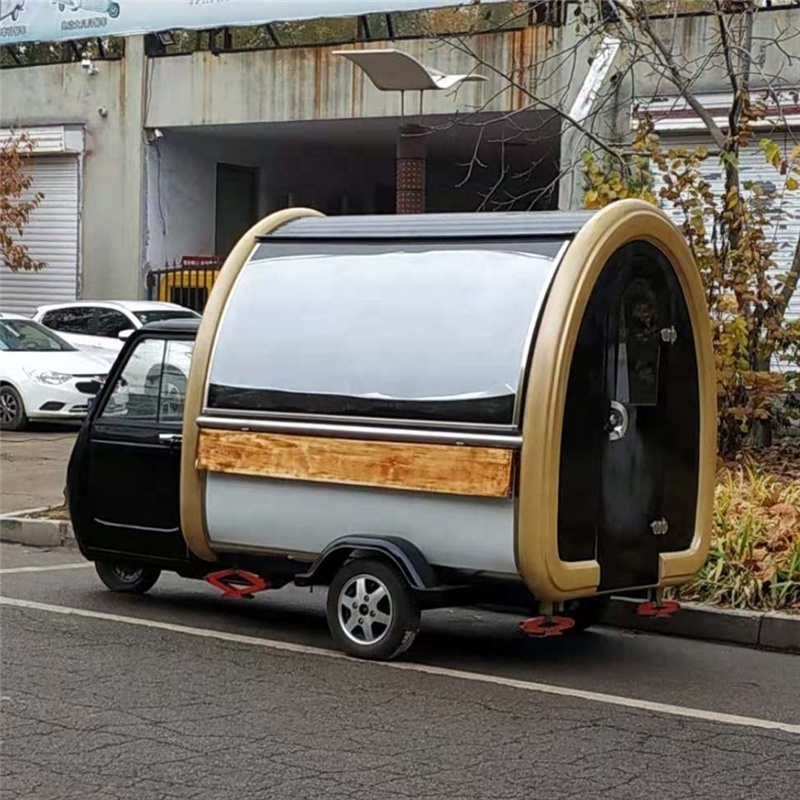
[0,314,108,431]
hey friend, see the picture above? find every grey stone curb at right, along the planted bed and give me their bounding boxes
[600,597,800,653]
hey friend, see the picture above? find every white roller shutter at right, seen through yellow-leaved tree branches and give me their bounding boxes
[662,134,800,319]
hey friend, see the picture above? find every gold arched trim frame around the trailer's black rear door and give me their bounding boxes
[517,200,716,602]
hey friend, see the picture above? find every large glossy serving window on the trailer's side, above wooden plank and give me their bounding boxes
[207,249,555,425]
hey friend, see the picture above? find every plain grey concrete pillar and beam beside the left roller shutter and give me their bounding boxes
[0,37,144,299]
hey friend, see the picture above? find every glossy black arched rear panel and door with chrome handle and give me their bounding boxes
[558,242,699,590]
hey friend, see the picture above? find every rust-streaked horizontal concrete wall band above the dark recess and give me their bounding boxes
[147,25,566,127]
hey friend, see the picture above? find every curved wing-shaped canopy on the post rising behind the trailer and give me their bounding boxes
[333,48,486,92]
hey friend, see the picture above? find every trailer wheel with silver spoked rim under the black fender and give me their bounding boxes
[327,558,420,661]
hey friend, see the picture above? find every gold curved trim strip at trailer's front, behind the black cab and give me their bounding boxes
[181,208,324,561]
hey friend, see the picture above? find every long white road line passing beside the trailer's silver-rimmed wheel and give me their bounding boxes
[0,597,800,736]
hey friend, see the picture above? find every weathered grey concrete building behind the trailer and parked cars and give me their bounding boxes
[0,0,800,312]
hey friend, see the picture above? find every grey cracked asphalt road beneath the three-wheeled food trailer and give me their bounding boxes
[0,545,800,800]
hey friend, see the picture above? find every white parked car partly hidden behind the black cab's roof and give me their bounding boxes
[33,300,199,365]
